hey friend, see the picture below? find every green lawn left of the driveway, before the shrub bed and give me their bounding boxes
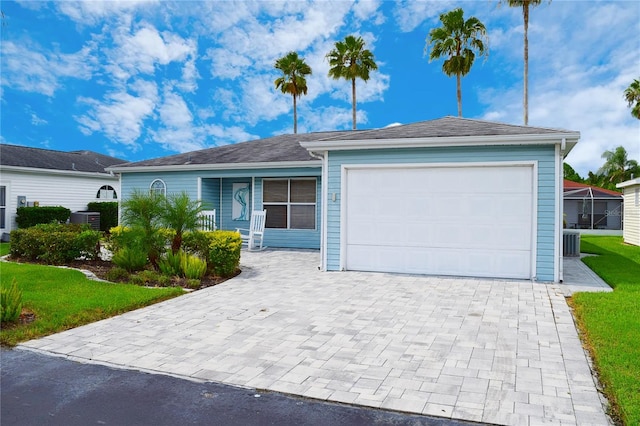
[0,260,184,346]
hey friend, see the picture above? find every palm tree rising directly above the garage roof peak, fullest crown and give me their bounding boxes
[425,8,489,117]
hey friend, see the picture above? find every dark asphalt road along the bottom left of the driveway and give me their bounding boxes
[0,349,477,426]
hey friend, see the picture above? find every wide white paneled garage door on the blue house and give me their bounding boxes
[342,165,534,278]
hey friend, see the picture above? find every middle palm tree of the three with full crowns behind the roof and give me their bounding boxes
[327,35,378,130]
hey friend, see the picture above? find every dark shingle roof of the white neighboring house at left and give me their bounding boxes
[0,144,125,173]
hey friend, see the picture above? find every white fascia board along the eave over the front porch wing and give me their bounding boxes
[107,160,322,173]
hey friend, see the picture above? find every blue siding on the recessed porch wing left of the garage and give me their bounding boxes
[121,167,322,249]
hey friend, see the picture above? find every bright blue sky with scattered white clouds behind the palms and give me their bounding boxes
[0,0,640,176]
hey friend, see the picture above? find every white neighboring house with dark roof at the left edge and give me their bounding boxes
[0,144,124,240]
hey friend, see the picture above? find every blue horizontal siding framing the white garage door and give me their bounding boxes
[326,145,556,281]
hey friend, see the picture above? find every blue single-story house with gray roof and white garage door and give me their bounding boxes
[108,117,580,282]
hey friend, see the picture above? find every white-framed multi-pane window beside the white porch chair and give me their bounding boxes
[262,179,316,229]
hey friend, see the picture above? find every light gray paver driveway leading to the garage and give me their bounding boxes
[22,250,609,425]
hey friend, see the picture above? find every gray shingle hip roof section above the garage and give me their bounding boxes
[325,117,567,140]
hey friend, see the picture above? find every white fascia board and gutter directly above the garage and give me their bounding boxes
[300,132,580,156]
